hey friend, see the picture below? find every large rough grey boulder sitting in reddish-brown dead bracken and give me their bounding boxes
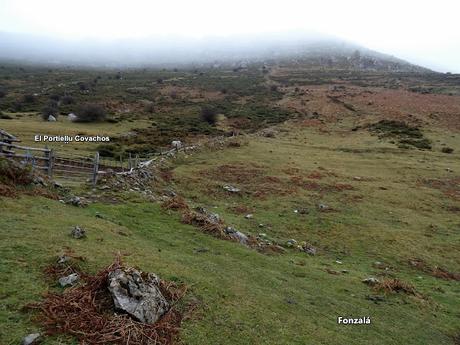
[108,268,169,323]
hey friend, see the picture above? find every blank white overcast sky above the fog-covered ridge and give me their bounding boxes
[0,0,460,73]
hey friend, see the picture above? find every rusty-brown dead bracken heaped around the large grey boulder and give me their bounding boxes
[30,258,191,345]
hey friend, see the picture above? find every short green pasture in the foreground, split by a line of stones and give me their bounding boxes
[0,118,460,345]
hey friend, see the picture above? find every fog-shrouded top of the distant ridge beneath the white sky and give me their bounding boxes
[0,32,431,72]
